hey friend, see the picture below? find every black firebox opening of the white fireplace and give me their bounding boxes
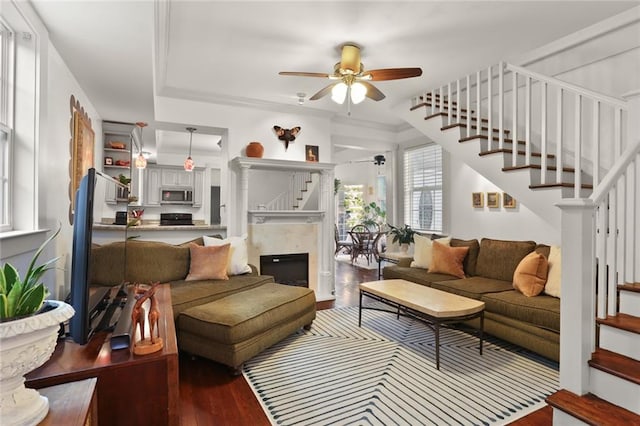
[260,253,309,287]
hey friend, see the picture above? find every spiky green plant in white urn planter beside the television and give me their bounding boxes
[0,228,75,425]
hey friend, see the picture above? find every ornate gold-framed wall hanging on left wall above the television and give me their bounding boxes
[69,95,95,225]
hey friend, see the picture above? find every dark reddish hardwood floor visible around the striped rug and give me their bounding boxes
[180,262,551,426]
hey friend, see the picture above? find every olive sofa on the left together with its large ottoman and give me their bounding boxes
[91,238,316,372]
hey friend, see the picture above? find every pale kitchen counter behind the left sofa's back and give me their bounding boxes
[92,222,227,244]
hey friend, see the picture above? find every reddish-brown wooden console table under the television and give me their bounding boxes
[26,284,179,426]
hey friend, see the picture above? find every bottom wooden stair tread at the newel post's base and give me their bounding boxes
[547,389,640,426]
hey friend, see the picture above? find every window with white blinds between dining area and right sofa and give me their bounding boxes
[404,144,442,232]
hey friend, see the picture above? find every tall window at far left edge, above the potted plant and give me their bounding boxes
[0,21,14,231]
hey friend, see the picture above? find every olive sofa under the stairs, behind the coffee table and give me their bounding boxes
[383,238,560,361]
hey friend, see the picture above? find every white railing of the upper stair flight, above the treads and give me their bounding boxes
[412,62,627,198]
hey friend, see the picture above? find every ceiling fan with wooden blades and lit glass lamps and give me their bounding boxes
[279,43,422,108]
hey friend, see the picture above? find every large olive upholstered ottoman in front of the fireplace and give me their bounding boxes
[177,283,316,373]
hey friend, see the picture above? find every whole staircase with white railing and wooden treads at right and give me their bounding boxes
[399,63,640,425]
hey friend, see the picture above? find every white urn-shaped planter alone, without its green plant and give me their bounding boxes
[0,300,75,426]
